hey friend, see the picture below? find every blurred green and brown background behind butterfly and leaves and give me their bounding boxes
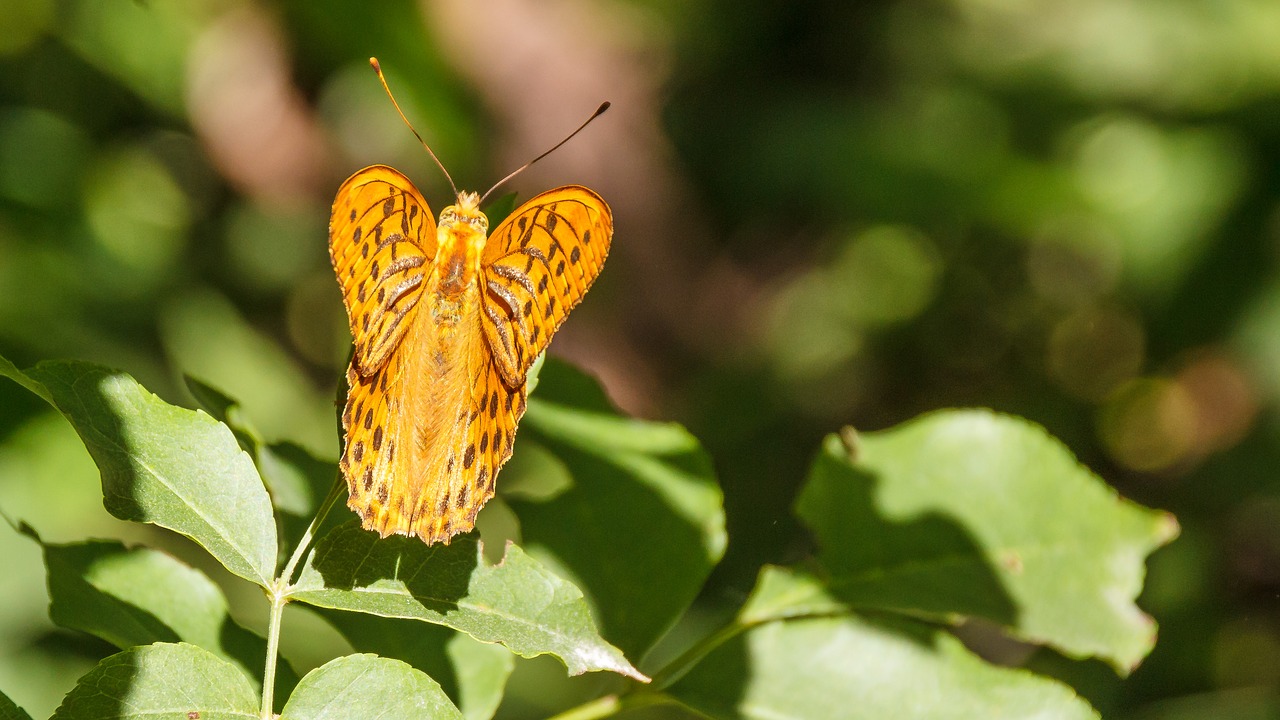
[0,0,1280,719]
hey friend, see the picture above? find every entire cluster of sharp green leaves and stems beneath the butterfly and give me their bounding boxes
[0,359,1176,720]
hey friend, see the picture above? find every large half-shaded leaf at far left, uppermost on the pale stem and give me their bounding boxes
[0,361,276,587]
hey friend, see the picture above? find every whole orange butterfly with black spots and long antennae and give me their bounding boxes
[329,59,613,544]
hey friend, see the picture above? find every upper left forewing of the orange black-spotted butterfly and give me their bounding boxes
[329,165,435,377]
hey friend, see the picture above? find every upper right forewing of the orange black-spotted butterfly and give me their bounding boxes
[480,186,613,384]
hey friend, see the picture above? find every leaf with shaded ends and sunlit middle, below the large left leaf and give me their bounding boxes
[37,538,298,697]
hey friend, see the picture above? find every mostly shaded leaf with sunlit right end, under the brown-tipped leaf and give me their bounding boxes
[320,610,516,720]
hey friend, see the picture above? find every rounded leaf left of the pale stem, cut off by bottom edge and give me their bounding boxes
[52,643,259,720]
